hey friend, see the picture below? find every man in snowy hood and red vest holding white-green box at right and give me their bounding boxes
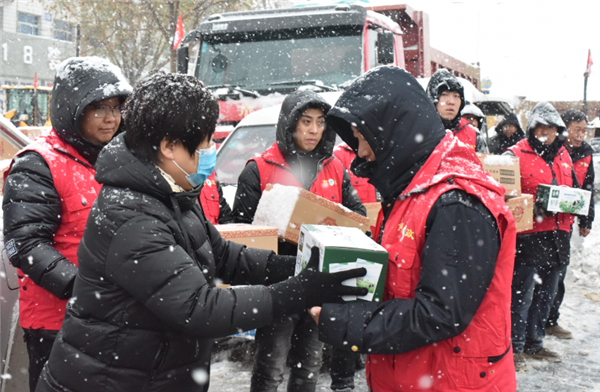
[504,102,574,370]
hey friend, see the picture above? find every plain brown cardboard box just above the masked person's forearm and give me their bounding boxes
[215,223,277,253]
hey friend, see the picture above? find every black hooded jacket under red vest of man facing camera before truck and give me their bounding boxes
[233,91,367,239]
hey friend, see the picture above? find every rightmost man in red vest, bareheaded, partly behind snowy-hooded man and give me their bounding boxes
[546,109,594,339]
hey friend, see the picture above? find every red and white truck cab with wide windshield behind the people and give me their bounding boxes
[178,5,404,138]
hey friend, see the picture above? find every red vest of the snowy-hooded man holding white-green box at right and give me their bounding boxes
[509,139,575,234]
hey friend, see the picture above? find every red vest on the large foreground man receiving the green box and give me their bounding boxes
[367,133,516,392]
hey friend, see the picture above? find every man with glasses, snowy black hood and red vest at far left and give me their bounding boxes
[2,57,131,391]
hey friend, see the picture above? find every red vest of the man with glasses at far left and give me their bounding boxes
[6,129,100,330]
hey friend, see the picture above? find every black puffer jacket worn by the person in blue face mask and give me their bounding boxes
[37,135,276,392]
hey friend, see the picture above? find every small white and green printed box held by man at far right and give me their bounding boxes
[536,185,592,215]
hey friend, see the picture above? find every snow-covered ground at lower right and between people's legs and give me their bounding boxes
[209,204,600,392]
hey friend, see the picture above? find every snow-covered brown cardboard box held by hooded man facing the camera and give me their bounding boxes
[252,184,370,244]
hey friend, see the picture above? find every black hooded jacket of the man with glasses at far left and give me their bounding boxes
[2,57,131,299]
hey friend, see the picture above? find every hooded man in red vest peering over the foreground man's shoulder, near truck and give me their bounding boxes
[427,68,489,154]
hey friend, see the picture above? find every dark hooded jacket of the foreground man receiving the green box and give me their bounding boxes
[319,66,500,354]
